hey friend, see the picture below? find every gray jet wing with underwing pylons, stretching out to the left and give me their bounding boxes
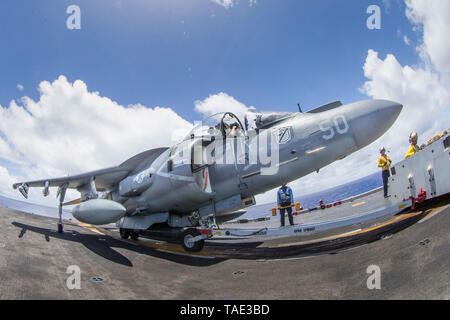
[13,166,132,191]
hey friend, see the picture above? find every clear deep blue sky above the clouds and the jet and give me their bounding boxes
[0,0,417,121]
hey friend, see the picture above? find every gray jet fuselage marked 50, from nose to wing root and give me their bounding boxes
[118,100,402,220]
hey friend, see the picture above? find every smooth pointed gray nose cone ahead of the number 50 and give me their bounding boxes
[353,100,403,148]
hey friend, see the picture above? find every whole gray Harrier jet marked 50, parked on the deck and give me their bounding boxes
[13,100,402,251]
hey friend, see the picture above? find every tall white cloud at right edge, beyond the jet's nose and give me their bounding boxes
[362,0,450,155]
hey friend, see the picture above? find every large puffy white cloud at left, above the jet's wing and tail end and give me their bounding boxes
[0,76,192,203]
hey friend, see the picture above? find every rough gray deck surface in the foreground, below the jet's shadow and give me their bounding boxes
[0,196,450,300]
